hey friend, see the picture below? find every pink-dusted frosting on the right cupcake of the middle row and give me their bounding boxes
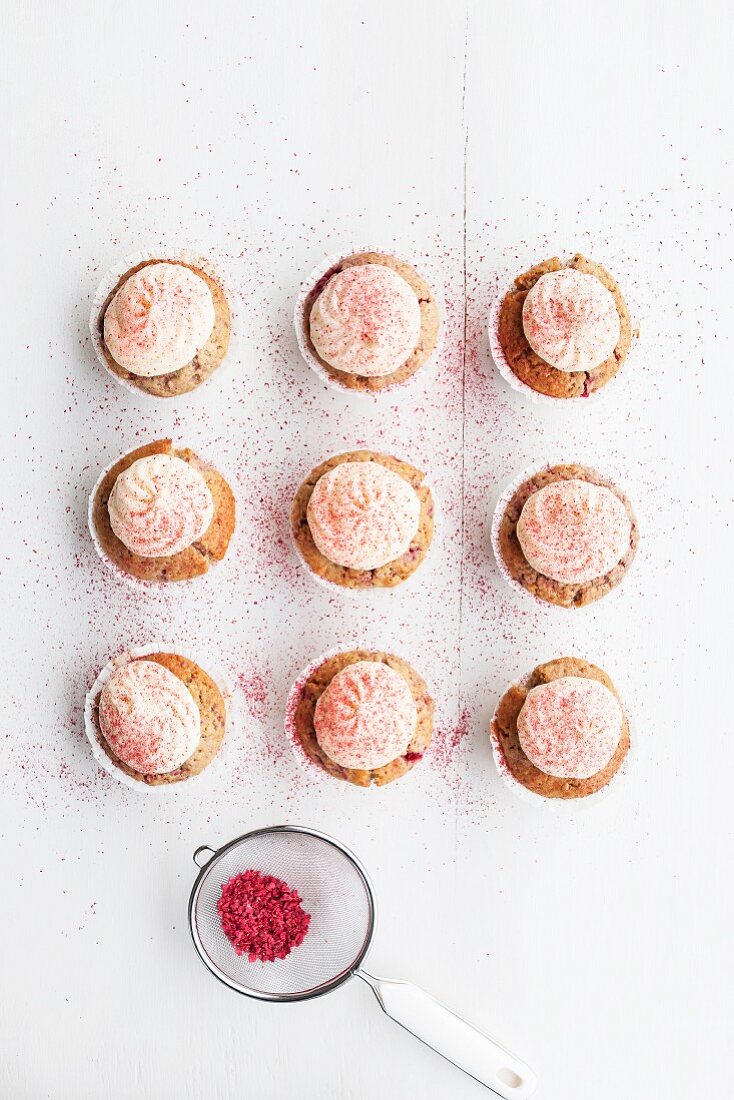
[517,477,632,584]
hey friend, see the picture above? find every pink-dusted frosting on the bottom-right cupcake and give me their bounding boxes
[517,677,624,779]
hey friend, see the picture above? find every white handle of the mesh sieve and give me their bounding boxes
[354,970,538,1100]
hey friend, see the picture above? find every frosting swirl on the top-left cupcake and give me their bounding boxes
[105,263,215,378]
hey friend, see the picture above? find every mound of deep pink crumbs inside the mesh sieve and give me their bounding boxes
[217,870,311,963]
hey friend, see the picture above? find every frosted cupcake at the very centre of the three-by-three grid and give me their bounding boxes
[291,451,435,589]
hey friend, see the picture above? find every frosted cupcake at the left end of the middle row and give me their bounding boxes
[89,439,234,582]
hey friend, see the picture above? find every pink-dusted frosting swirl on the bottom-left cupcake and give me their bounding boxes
[99,660,201,776]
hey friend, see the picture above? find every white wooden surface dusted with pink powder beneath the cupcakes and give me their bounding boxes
[0,0,734,1100]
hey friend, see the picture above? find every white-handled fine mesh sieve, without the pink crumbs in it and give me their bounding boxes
[188,825,537,1100]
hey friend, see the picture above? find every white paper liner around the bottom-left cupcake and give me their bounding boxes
[84,641,234,798]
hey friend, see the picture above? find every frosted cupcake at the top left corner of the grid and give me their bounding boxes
[91,259,231,397]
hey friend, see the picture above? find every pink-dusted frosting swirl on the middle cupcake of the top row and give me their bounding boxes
[309,264,420,378]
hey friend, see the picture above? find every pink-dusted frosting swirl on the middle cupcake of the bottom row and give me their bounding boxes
[314,661,417,769]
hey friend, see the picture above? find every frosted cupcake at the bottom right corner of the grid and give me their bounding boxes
[492,657,629,799]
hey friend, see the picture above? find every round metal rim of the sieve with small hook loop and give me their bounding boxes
[188,825,376,1004]
